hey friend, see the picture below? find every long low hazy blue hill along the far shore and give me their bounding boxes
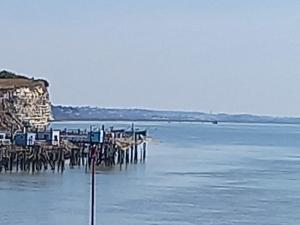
[52,106,300,124]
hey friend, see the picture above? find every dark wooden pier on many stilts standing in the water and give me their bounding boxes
[0,127,147,173]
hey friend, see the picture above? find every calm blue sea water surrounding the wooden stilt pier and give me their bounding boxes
[0,122,300,225]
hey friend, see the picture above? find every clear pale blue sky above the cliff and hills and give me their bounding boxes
[0,0,300,116]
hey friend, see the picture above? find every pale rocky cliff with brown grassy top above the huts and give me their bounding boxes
[0,71,52,131]
